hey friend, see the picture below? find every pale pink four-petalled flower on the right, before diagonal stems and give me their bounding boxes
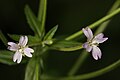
[82,27,108,60]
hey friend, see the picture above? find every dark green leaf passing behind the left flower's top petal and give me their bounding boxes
[8,34,41,45]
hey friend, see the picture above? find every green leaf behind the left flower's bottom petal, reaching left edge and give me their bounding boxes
[0,50,27,65]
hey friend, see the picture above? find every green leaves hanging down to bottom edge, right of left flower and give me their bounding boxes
[25,47,47,80]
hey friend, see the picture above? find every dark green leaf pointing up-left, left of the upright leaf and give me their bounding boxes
[25,5,41,38]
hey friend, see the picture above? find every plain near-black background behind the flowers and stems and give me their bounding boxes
[0,0,120,80]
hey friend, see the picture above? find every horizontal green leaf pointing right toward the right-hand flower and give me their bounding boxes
[51,40,82,51]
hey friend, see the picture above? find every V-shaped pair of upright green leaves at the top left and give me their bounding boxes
[25,0,47,40]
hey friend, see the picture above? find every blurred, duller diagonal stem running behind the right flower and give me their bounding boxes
[68,0,120,76]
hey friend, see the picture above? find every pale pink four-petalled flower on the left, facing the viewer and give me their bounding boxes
[8,36,34,63]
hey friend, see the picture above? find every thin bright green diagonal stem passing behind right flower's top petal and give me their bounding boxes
[65,8,120,40]
